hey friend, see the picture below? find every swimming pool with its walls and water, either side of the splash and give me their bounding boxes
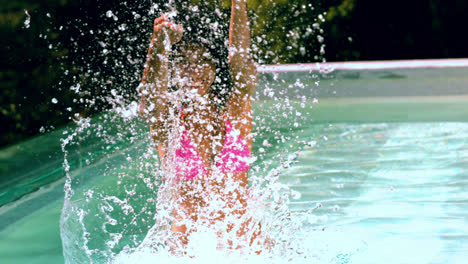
[0,60,468,263]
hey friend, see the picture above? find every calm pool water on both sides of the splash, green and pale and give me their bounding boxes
[0,118,468,263]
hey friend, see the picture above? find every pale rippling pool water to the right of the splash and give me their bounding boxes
[283,123,468,263]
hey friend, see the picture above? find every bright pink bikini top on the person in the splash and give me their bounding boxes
[175,118,250,180]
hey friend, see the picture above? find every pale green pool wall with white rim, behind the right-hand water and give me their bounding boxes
[258,59,468,123]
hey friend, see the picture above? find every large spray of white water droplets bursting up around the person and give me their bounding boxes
[55,1,362,263]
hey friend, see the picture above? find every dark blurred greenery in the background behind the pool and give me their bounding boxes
[0,0,468,147]
